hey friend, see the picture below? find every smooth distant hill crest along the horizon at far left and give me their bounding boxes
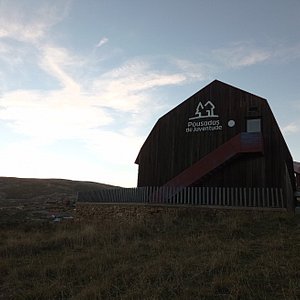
[0,177,115,199]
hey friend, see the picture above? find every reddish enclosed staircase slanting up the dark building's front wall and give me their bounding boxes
[164,132,263,187]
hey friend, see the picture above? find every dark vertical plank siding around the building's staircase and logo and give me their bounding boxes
[136,80,296,211]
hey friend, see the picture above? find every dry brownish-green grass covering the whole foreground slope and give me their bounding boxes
[0,209,300,300]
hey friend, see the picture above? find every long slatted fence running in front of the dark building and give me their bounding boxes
[77,187,286,208]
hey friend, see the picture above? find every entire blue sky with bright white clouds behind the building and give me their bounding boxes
[0,0,300,187]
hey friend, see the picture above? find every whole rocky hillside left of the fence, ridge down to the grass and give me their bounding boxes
[0,177,113,225]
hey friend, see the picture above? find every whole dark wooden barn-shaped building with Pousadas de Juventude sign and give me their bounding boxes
[136,80,296,208]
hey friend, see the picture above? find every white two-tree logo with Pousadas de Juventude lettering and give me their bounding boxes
[185,101,222,133]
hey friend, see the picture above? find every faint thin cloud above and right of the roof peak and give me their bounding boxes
[212,43,272,68]
